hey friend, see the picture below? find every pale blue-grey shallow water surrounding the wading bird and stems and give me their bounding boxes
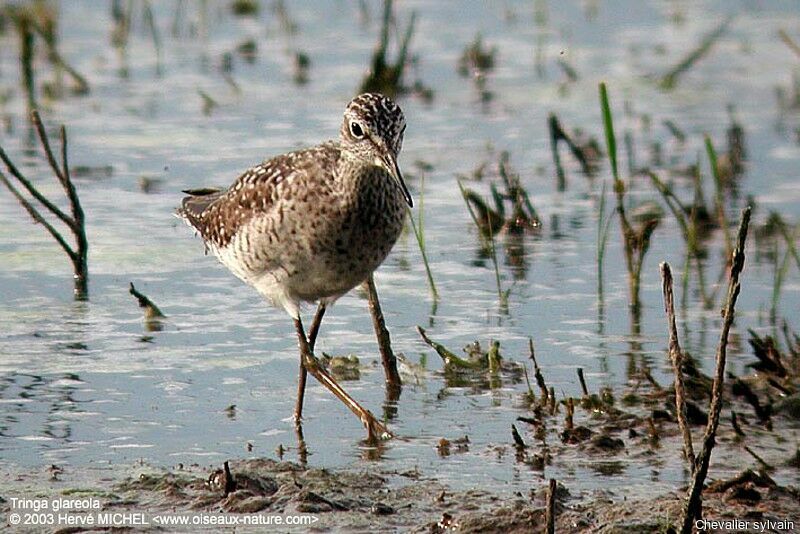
[0,0,800,502]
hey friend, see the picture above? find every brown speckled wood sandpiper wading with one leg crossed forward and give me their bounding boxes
[177,93,413,439]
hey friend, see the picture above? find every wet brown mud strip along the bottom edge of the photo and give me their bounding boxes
[2,450,800,533]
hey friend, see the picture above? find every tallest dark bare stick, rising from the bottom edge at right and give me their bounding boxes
[681,206,750,534]
